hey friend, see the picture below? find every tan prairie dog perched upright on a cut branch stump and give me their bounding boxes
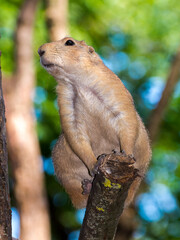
[38,37,151,208]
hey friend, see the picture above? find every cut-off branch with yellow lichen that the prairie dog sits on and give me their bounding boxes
[79,153,138,240]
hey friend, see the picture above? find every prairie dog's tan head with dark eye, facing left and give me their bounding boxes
[38,37,101,79]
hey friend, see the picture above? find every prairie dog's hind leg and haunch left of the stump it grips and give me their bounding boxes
[52,135,91,208]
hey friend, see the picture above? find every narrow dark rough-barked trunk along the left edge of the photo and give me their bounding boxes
[0,52,12,240]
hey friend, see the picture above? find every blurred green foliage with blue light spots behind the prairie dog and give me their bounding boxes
[0,0,180,240]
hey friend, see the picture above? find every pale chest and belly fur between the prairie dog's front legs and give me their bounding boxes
[74,86,120,152]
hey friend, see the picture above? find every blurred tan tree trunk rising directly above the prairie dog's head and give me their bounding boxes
[46,0,68,41]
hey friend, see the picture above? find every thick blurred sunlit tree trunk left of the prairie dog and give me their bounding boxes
[4,0,50,240]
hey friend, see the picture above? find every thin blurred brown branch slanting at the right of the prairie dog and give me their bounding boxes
[148,50,180,143]
